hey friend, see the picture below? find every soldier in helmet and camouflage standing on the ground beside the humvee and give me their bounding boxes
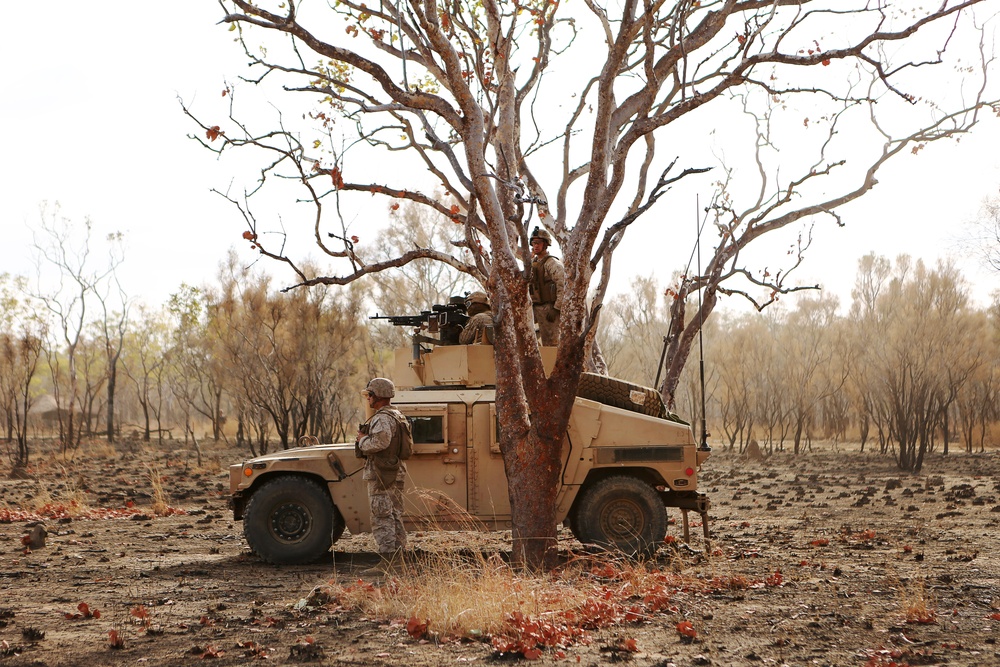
[355,378,409,567]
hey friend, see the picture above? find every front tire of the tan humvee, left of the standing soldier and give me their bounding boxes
[243,475,334,565]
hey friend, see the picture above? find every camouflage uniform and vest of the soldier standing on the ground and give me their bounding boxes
[358,406,406,556]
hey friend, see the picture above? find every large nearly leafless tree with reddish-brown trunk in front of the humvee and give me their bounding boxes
[186,0,989,566]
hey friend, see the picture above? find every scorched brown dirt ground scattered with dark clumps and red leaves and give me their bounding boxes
[0,440,1000,667]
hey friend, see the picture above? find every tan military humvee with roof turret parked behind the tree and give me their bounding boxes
[229,344,710,564]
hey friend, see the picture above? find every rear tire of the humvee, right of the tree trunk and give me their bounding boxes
[570,475,667,556]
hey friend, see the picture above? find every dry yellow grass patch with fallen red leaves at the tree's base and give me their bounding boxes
[324,493,718,655]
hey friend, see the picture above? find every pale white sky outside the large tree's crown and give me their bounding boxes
[0,0,1000,316]
